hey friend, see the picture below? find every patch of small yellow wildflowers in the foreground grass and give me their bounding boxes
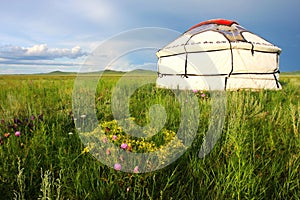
[83,119,185,173]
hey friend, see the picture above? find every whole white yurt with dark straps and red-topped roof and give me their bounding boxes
[156,19,281,90]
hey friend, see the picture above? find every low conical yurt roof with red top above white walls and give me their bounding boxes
[157,19,281,57]
